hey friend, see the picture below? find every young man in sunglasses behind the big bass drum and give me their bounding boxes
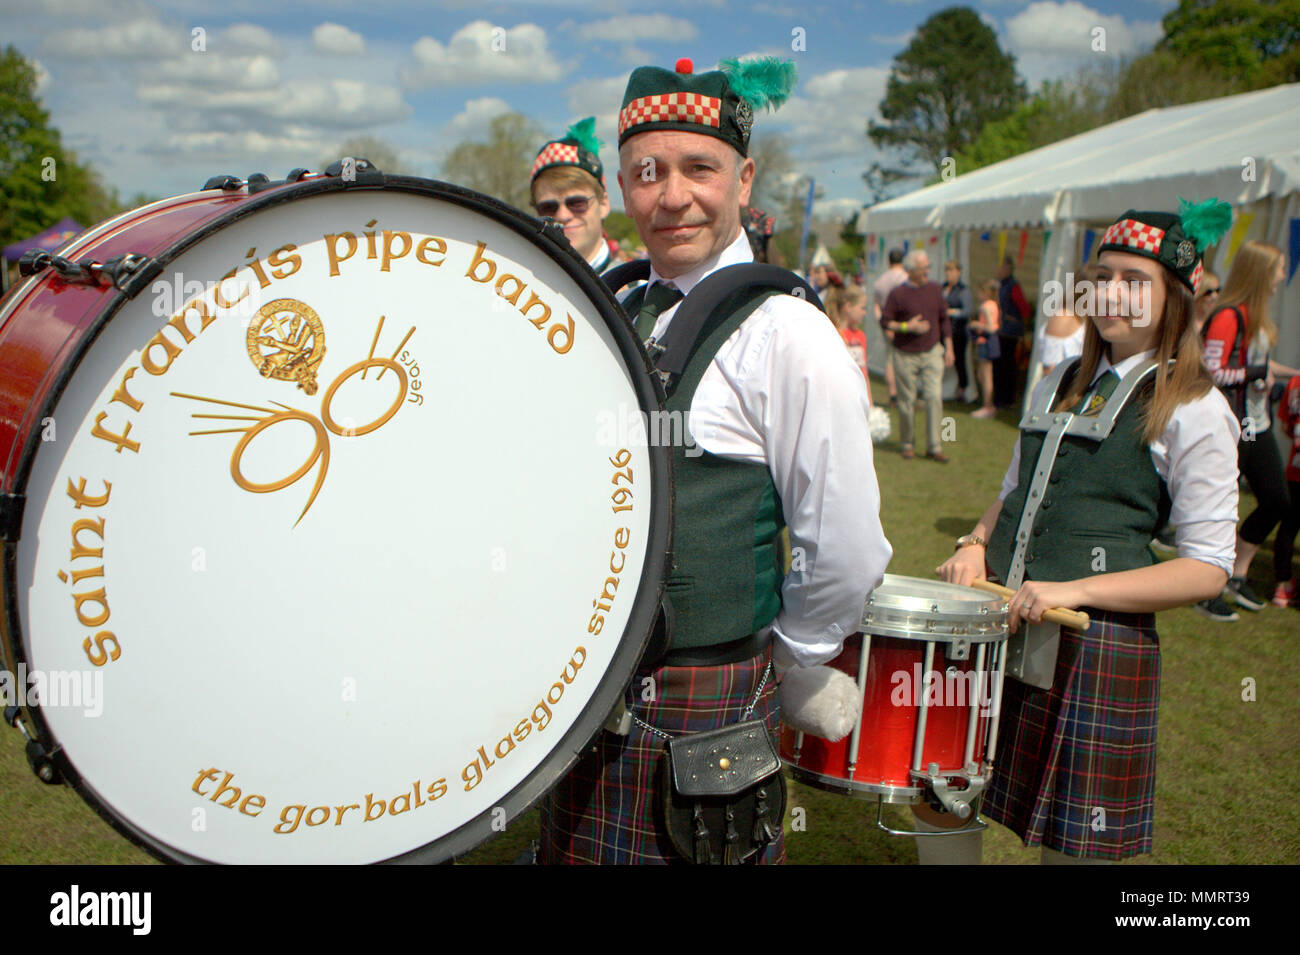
[532,117,616,274]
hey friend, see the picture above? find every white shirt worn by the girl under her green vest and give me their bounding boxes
[998,351,1242,576]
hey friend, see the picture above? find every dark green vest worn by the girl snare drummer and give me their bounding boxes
[988,378,1170,581]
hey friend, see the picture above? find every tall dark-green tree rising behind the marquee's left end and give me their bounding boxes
[867,6,1026,172]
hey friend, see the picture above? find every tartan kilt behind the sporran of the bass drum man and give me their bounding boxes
[538,647,785,865]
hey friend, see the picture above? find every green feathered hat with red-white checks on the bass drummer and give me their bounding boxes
[619,56,796,156]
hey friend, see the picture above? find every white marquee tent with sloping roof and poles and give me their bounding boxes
[857,83,1300,405]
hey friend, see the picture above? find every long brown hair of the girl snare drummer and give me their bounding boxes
[1056,253,1216,444]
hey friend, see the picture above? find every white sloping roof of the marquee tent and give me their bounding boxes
[857,83,1300,234]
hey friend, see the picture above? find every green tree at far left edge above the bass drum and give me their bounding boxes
[0,45,122,244]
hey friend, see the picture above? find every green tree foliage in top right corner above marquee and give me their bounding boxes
[1157,0,1300,88]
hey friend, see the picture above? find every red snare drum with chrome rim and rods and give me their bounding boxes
[781,574,1006,819]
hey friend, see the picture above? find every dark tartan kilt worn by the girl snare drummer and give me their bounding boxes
[983,608,1160,860]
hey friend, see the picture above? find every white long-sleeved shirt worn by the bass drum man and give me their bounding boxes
[629,230,893,668]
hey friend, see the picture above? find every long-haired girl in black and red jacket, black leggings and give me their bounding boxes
[1197,240,1300,620]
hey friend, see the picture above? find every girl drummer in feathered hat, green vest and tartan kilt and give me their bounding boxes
[918,200,1239,861]
